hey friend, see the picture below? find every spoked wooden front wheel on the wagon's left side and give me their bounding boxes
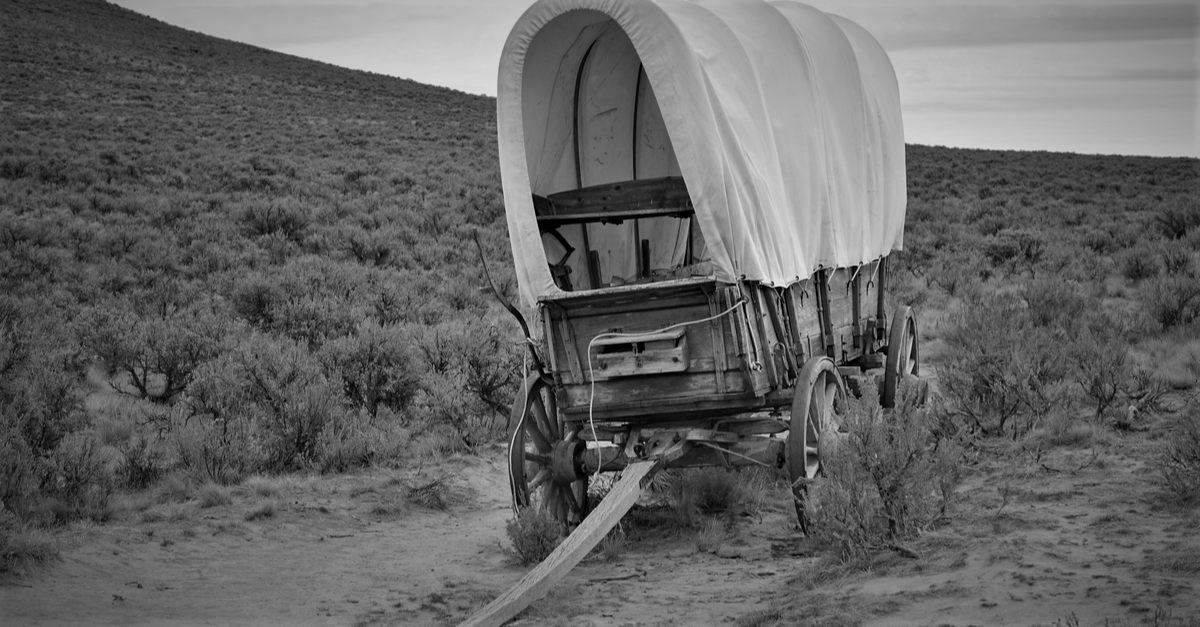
[509,372,588,525]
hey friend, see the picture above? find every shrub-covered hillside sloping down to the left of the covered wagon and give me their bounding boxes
[0,0,520,515]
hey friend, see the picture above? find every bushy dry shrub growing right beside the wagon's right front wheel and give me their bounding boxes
[809,386,962,562]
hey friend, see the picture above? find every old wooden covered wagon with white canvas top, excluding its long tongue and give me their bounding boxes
[497,0,918,525]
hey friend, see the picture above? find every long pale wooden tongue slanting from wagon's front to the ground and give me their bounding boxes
[460,461,660,627]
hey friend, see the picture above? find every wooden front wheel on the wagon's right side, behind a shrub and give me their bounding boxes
[787,357,846,535]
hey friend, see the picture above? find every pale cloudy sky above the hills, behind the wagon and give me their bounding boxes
[108,0,1200,157]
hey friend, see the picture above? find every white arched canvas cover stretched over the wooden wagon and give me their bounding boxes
[497,0,906,305]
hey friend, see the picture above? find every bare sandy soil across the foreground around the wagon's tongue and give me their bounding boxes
[0,434,1200,626]
